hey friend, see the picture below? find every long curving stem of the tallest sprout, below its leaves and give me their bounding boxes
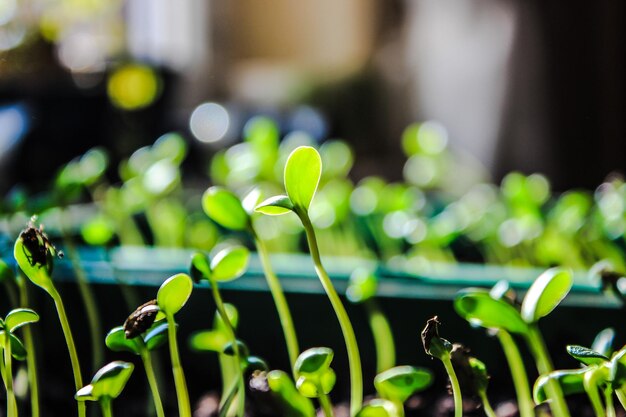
[296,211,363,416]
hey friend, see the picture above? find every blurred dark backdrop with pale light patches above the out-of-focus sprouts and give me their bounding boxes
[0,0,626,194]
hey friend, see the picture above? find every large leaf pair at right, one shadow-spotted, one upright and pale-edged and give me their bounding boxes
[454,268,573,334]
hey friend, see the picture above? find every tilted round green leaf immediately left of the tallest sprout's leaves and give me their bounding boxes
[202,186,250,230]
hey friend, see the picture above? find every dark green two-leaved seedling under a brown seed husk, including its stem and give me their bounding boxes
[105,316,168,417]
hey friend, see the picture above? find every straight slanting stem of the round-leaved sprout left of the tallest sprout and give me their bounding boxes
[252,234,300,375]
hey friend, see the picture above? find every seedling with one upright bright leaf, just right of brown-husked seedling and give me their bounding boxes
[157,274,193,417]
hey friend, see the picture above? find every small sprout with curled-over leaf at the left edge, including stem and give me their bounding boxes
[0,308,39,417]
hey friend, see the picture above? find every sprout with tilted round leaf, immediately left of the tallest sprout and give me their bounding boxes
[202,186,300,369]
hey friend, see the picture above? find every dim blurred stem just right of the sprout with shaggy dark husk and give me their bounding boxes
[63,233,104,369]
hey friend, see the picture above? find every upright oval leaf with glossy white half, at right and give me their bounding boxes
[522,268,574,323]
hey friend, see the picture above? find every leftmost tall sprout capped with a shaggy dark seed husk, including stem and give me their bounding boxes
[13,223,86,417]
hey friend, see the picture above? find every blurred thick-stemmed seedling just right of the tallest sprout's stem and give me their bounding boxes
[346,268,396,373]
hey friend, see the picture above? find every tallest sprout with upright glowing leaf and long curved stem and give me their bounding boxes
[256,146,363,416]
